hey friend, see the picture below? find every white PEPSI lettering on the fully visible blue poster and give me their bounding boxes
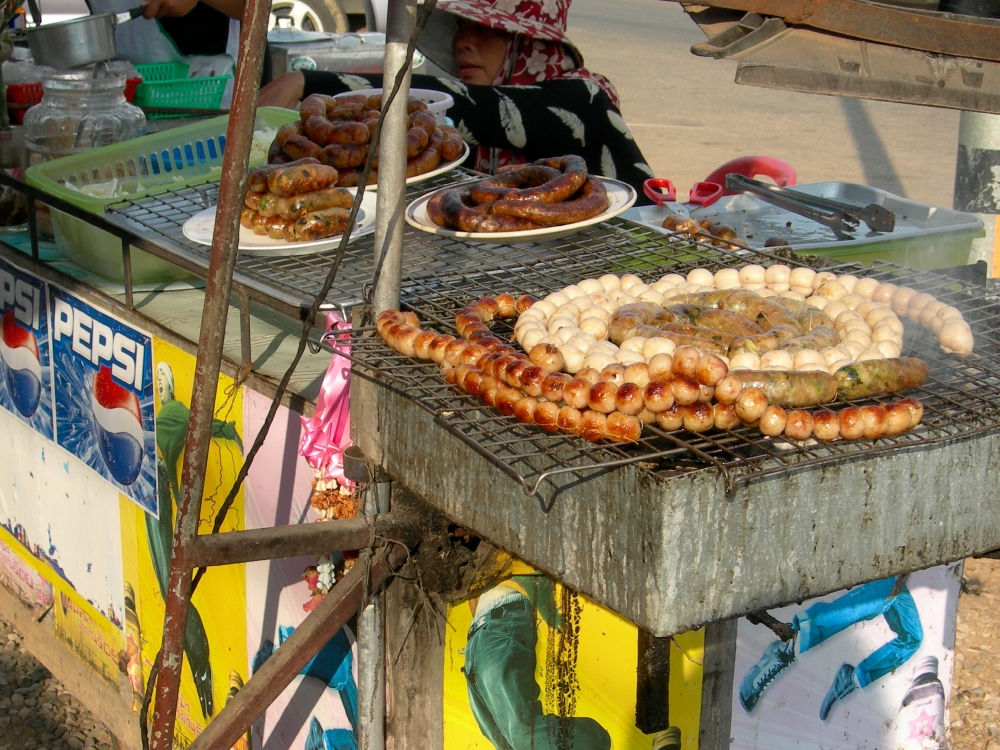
[52,298,146,392]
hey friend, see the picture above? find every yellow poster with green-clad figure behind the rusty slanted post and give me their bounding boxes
[120,339,247,748]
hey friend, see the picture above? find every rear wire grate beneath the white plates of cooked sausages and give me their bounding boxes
[107,170,852,312]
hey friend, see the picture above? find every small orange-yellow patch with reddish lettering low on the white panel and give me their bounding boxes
[54,586,124,690]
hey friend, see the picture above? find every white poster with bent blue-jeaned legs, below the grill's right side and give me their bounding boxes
[731,563,961,750]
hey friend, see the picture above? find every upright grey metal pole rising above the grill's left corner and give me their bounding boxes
[372,0,417,314]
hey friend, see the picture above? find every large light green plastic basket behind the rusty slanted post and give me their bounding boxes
[25,107,299,284]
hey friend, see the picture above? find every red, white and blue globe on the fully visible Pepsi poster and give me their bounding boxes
[91,366,145,484]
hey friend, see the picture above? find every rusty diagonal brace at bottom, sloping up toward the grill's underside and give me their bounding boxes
[189,544,409,750]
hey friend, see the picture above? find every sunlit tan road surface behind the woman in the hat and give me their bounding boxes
[569,0,958,207]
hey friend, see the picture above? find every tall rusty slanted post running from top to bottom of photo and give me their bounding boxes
[149,0,271,750]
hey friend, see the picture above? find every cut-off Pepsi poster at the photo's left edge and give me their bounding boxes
[0,260,54,440]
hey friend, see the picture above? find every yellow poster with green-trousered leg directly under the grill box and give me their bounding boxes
[444,574,704,750]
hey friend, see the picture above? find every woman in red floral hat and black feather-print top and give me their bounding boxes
[259,0,653,202]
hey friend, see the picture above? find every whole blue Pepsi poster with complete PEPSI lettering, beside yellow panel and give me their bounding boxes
[48,284,158,516]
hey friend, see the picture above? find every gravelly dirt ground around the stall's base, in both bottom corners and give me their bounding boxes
[0,560,1000,750]
